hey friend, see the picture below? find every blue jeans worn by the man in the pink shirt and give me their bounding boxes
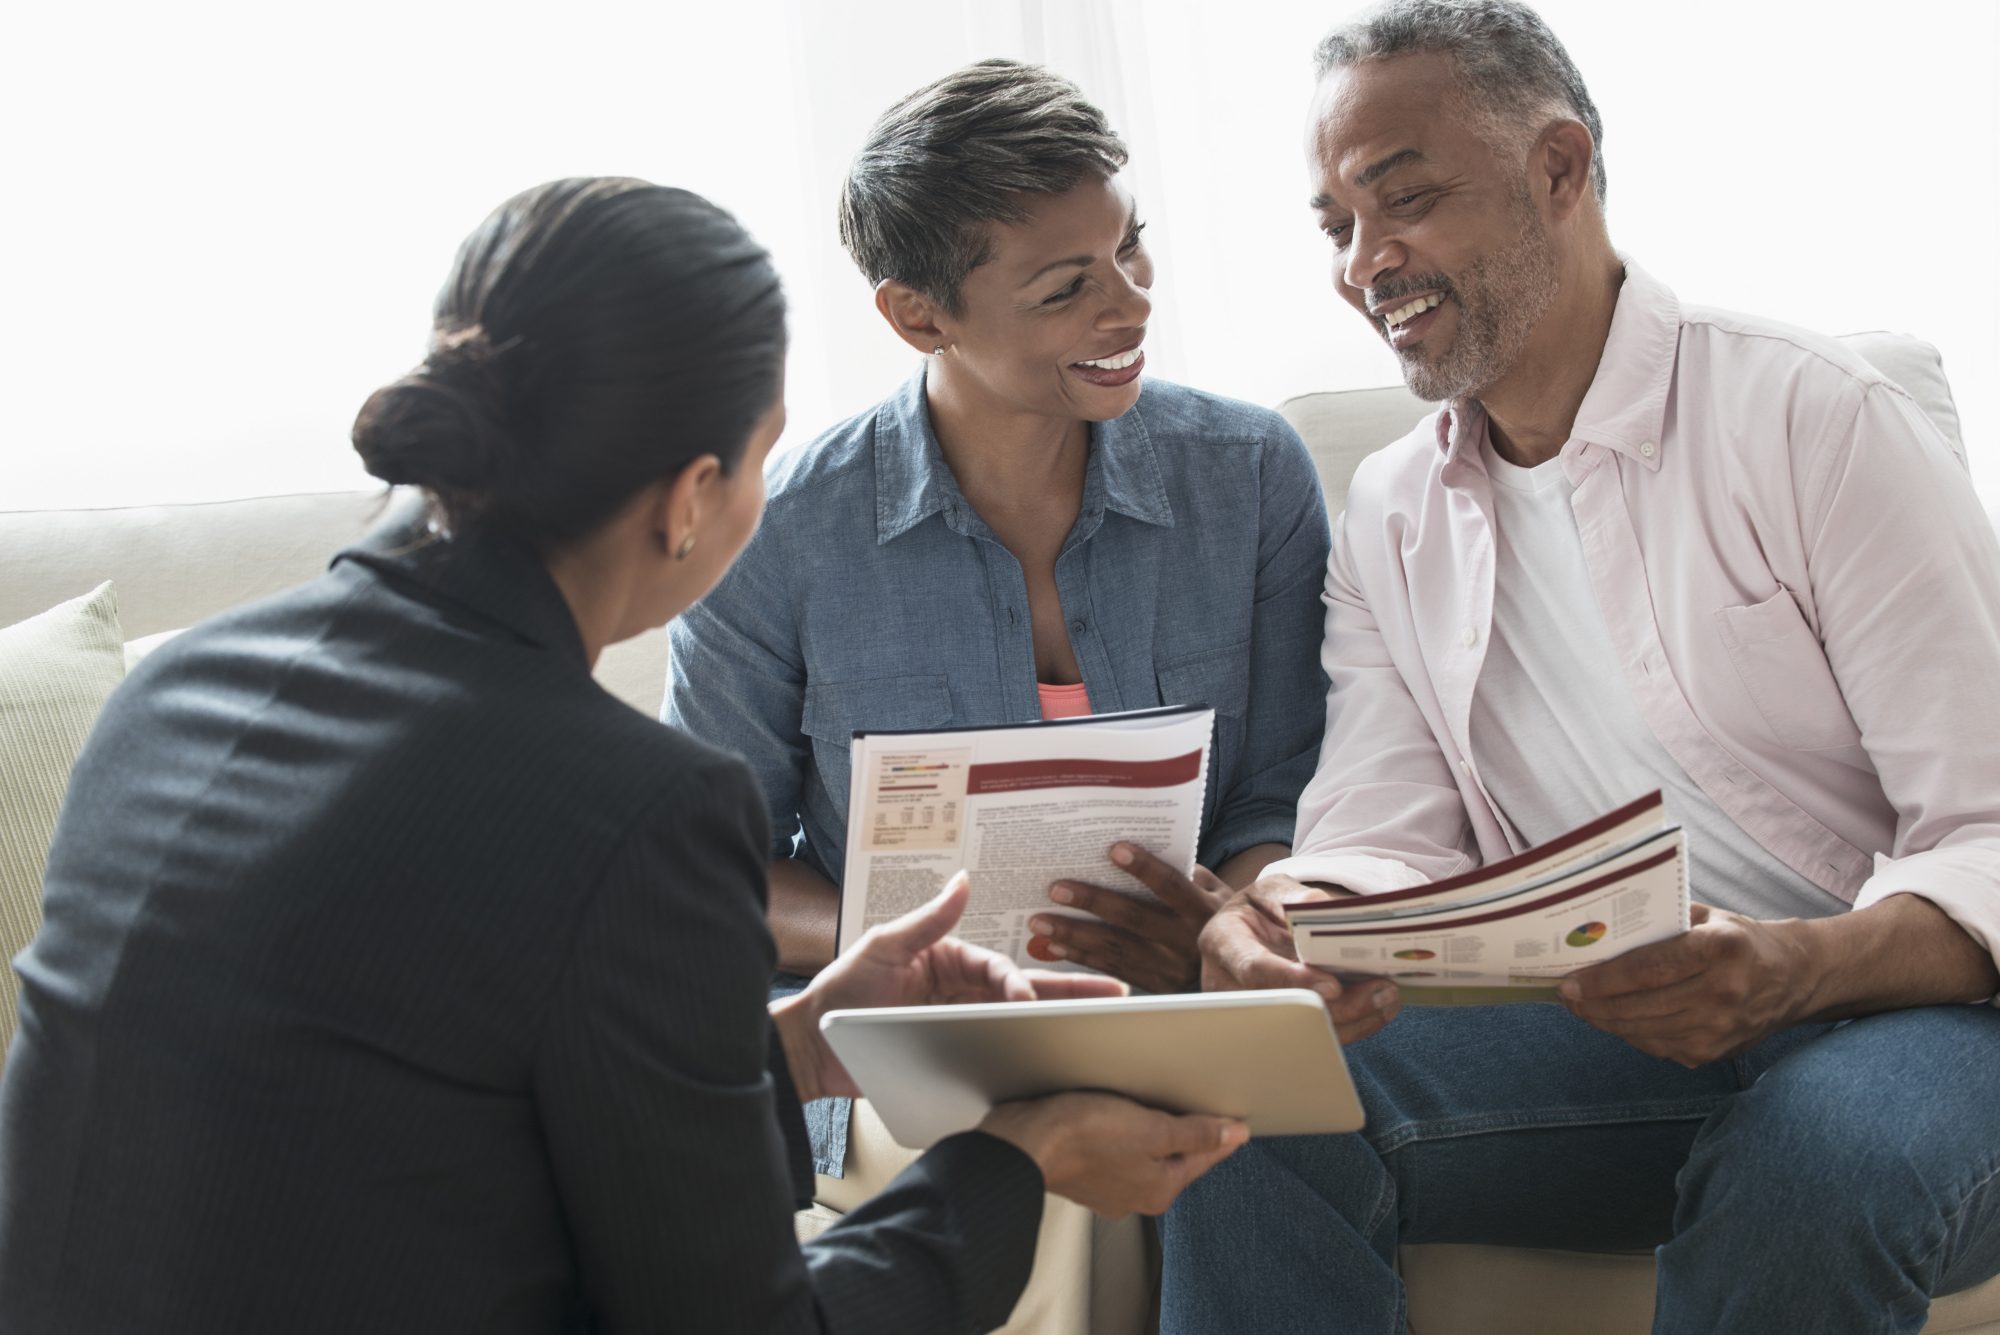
[1160,1005,2000,1335]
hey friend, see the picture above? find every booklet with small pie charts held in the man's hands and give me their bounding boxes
[1286,793,1688,1005]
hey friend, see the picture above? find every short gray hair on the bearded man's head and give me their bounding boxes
[1316,0,1604,204]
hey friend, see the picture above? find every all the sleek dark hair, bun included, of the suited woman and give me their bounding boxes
[354,176,786,548]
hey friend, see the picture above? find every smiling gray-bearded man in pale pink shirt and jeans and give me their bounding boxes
[1162,0,2000,1335]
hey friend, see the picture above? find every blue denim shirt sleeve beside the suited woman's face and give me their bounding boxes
[660,526,810,857]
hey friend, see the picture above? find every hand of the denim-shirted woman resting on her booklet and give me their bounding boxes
[1028,843,1232,991]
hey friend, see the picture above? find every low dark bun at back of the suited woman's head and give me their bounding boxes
[352,326,514,510]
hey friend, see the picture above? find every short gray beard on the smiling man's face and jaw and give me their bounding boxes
[1398,192,1562,402]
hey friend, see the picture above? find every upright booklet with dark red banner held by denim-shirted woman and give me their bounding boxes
[838,705,1216,969]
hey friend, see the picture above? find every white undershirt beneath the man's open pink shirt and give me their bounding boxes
[1470,433,1846,917]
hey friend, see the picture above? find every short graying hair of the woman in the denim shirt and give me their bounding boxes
[840,60,1126,314]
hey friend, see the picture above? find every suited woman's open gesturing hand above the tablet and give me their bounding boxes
[770,871,1126,1099]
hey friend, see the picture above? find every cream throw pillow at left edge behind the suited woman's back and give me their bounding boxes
[0,584,124,1053]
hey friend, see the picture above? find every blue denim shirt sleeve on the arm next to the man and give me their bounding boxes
[1202,420,1328,867]
